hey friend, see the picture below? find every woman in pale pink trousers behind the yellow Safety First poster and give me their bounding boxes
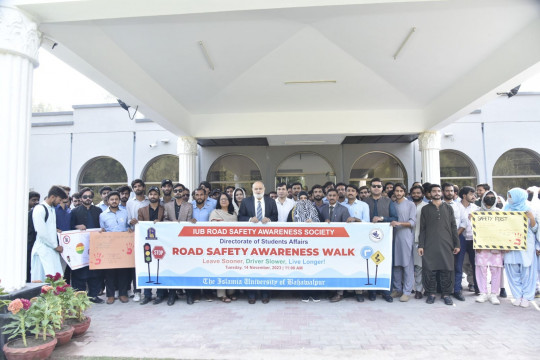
[475,190,504,305]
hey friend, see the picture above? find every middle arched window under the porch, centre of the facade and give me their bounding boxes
[276,152,336,190]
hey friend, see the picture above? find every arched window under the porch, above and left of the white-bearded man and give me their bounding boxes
[206,154,262,194]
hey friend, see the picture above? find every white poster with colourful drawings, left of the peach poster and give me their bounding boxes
[58,229,100,270]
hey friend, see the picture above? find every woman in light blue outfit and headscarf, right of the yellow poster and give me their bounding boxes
[504,188,538,308]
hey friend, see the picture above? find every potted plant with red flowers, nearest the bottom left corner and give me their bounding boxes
[2,297,57,360]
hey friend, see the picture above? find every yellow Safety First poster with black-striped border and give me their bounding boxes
[471,211,529,250]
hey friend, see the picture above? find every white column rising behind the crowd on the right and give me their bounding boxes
[418,131,441,185]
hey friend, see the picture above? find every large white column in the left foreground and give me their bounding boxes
[0,5,41,291]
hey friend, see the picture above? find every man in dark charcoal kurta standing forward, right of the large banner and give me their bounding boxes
[418,184,459,305]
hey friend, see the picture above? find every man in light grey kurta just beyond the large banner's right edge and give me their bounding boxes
[390,183,416,302]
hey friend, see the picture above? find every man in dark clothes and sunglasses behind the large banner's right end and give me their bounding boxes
[364,178,398,302]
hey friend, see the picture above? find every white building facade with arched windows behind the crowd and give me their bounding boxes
[29,93,540,198]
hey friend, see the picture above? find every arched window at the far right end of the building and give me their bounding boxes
[493,149,540,198]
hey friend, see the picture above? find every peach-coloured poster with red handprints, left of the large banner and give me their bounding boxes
[89,232,135,270]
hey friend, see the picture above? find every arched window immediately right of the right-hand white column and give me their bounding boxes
[439,150,477,189]
